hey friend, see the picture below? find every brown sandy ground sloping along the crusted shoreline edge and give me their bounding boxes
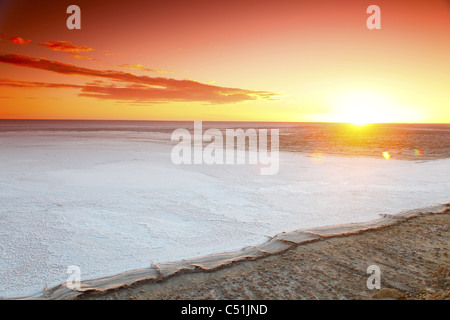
[79,213,450,300]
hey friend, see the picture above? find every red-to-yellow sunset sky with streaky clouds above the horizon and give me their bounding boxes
[0,0,450,124]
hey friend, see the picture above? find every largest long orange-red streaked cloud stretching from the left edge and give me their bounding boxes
[0,54,277,104]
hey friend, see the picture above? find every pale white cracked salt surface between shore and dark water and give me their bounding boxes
[0,132,450,297]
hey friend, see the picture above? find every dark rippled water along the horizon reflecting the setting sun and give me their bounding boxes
[0,120,450,160]
